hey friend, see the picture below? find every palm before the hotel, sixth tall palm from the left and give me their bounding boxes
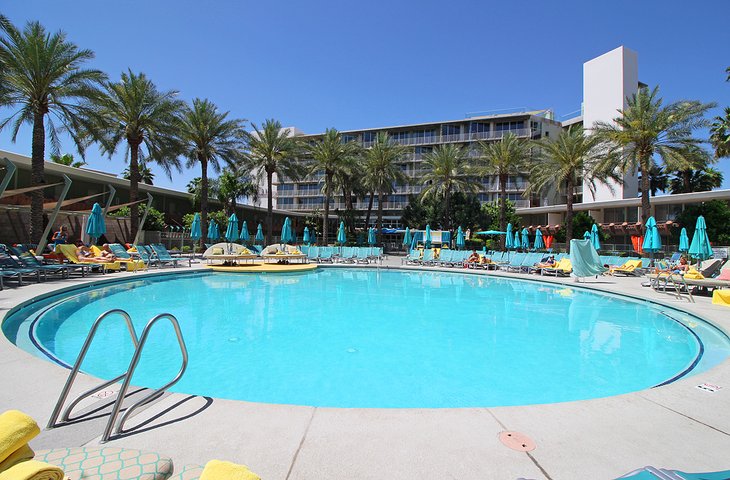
[364,132,410,241]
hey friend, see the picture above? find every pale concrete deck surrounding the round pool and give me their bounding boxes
[0,257,730,480]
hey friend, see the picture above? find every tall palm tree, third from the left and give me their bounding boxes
[180,98,246,247]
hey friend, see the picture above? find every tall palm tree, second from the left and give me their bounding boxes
[89,70,185,242]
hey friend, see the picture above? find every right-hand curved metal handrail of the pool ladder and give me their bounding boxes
[101,313,188,443]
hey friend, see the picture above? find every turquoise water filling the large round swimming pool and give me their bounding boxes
[3,269,730,408]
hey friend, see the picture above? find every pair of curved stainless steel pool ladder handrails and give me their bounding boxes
[47,308,188,443]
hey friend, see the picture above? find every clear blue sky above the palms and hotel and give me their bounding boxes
[0,0,730,189]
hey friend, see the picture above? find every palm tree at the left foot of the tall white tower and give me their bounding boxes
[525,126,619,251]
